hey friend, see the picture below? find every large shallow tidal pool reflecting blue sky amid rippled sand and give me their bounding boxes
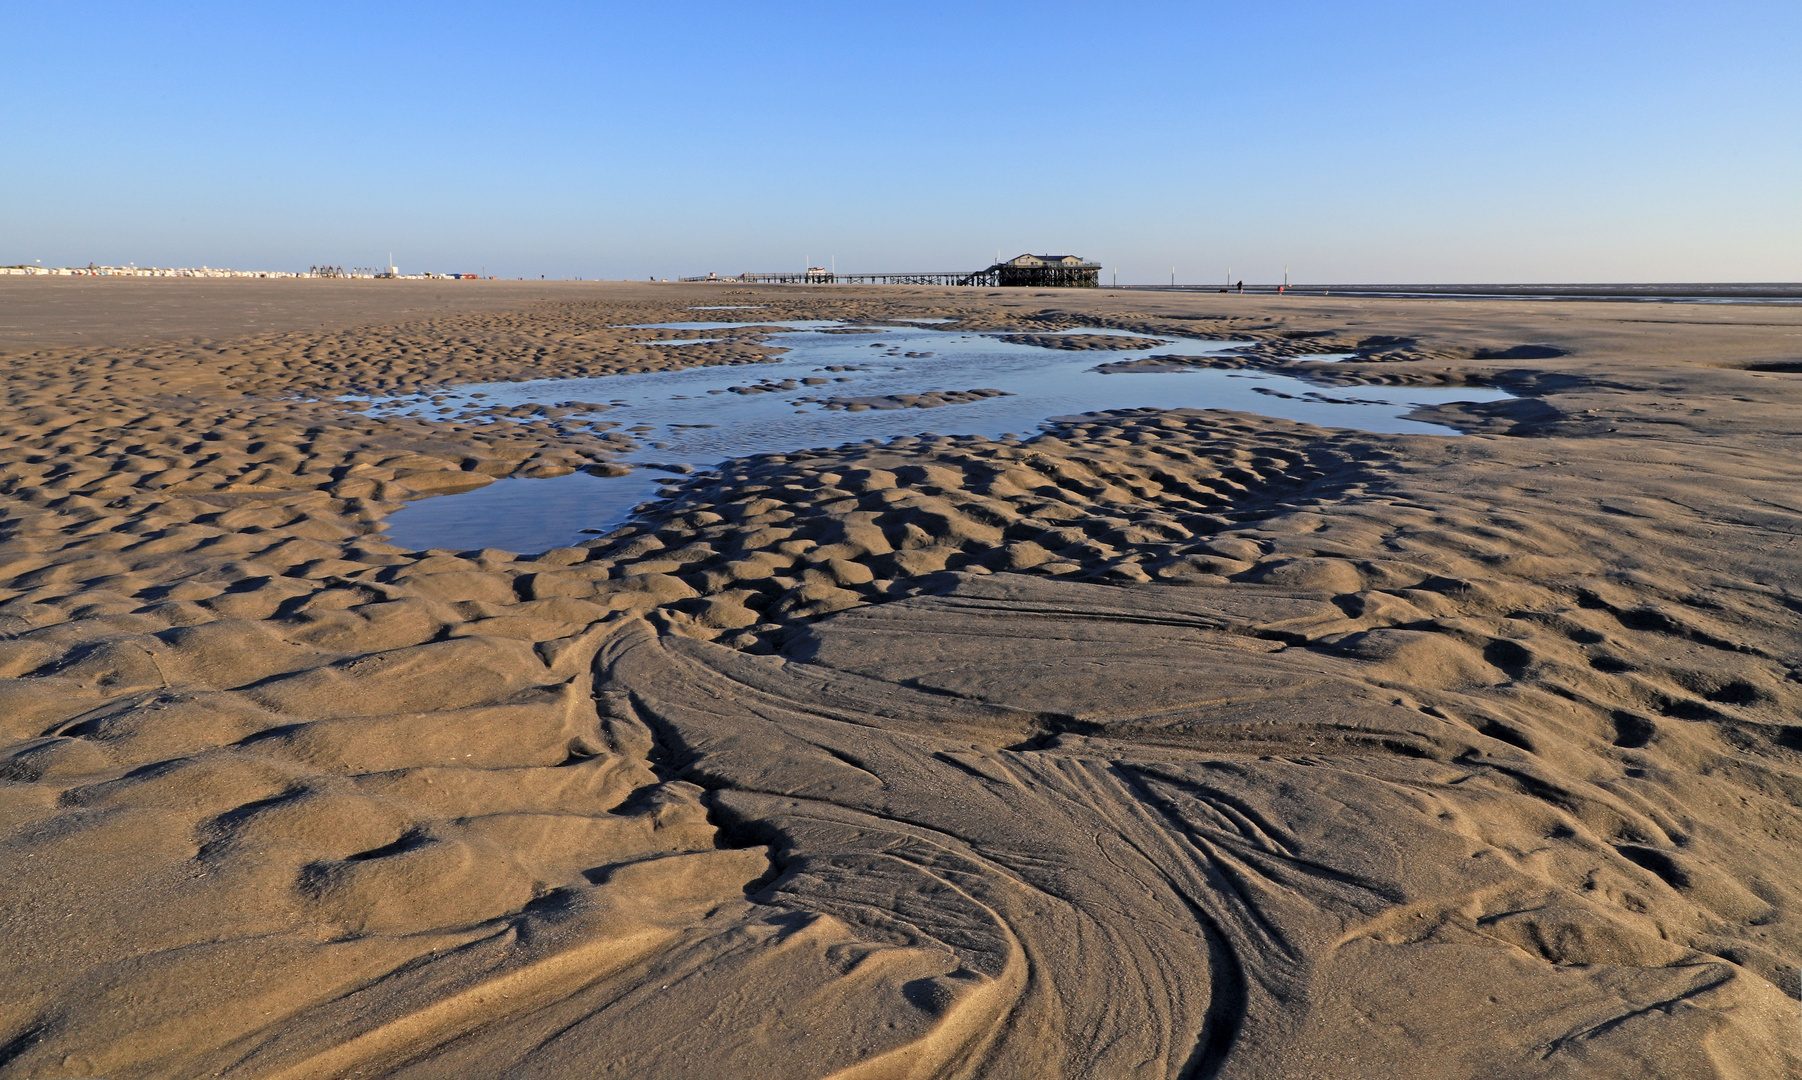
[368,319,1510,552]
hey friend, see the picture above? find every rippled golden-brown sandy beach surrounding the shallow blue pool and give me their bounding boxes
[0,278,1802,1080]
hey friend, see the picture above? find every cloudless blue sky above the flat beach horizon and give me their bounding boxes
[0,0,1802,283]
